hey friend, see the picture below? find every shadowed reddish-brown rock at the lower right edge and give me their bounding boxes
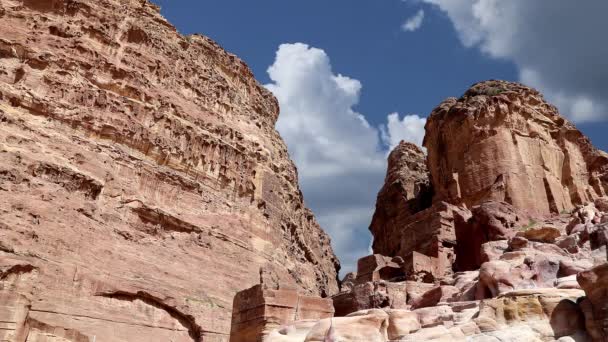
[577,264,608,341]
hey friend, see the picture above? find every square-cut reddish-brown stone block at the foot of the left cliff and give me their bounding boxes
[230,284,334,342]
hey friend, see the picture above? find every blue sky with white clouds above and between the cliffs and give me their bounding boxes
[150,0,608,271]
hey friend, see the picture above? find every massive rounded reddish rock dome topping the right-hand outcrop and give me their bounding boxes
[424,81,608,214]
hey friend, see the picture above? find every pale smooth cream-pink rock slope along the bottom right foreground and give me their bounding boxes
[269,289,591,342]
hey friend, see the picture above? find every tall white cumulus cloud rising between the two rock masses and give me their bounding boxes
[266,43,424,274]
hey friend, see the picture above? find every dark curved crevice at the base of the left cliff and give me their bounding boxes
[95,291,205,342]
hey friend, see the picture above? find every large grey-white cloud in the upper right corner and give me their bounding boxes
[422,0,608,122]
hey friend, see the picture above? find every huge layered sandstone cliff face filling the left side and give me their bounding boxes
[0,0,339,342]
